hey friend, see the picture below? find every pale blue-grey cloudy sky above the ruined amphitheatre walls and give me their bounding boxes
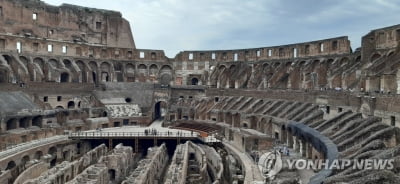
[44,0,400,57]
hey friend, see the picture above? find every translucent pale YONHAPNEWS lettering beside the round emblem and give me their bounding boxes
[286,159,394,170]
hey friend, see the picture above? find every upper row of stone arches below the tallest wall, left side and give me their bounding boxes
[0,55,174,83]
